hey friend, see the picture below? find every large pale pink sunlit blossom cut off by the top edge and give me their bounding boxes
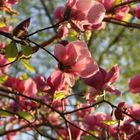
[55,0,106,30]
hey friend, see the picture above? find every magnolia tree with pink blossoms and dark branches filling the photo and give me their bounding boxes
[0,0,140,140]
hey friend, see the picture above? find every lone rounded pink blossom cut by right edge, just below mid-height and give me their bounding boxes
[129,75,140,93]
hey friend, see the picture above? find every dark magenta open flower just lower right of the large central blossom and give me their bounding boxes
[83,65,120,95]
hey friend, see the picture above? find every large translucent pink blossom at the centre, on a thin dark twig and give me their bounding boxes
[54,41,98,78]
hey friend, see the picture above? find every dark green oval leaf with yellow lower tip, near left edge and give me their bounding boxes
[6,41,18,61]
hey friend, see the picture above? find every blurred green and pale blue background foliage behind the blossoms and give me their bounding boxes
[0,0,140,139]
